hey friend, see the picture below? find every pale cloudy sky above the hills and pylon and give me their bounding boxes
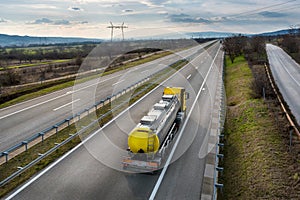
[0,0,300,39]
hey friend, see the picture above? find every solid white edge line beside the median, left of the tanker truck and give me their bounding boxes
[7,43,211,200]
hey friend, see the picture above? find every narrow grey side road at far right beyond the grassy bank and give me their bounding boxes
[266,44,300,124]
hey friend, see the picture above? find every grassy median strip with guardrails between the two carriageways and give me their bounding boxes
[0,58,187,197]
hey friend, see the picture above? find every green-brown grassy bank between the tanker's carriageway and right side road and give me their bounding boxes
[218,57,299,200]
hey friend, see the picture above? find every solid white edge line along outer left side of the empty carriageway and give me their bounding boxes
[0,74,122,120]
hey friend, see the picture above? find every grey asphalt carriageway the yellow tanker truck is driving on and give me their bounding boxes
[7,43,223,200]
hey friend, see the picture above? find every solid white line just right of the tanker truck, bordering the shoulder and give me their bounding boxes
[149,44,220,200]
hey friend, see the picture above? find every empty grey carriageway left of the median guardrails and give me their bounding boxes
[0,43,213,151]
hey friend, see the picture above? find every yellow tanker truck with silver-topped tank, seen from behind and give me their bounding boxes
[123,87,188,172]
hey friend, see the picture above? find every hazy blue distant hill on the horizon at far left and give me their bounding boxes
[0,34,103,47]
